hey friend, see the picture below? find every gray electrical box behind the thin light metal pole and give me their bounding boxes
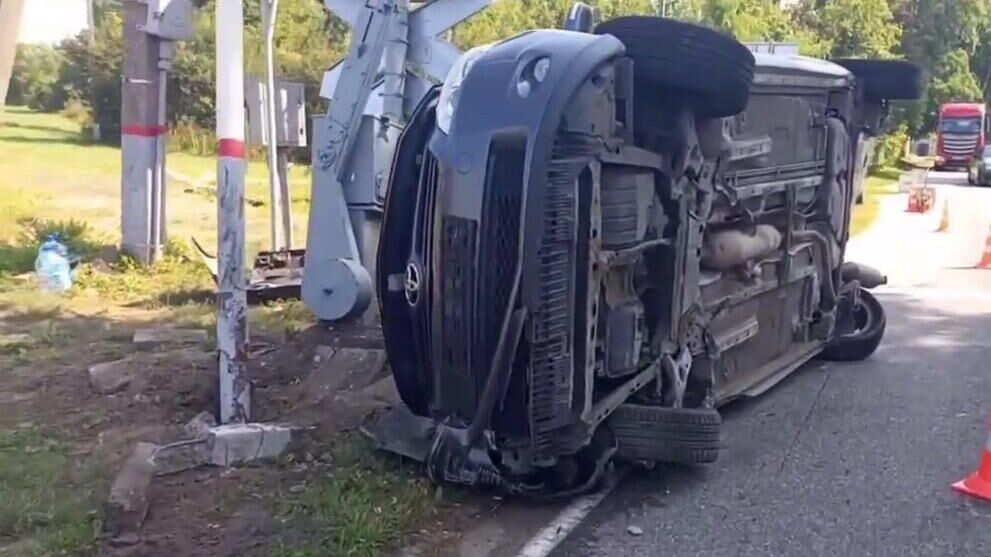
[244,75,306,147]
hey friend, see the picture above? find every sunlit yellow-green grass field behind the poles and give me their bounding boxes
[0,107,310,254]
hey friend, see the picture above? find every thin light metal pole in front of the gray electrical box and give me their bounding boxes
[260,0,289,251]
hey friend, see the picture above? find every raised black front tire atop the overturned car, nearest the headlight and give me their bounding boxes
[595,16,755,118]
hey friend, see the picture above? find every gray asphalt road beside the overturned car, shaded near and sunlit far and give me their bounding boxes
[553,169,991,557]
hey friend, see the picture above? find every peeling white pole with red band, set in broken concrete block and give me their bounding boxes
[216,0,251,423]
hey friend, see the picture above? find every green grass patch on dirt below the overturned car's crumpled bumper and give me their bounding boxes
[272,438,435,557]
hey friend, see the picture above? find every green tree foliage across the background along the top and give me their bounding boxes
[11,0,991,146]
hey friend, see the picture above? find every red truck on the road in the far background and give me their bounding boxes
[936,103,991,170]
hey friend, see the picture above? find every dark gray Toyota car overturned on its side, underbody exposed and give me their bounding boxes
[367,17,920,496]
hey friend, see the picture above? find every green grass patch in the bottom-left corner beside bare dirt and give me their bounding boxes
[0,429,102,556]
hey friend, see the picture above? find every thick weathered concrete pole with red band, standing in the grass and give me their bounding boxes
[121,0,168,264]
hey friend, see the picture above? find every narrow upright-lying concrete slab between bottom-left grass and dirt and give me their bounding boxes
[103,443,158,538]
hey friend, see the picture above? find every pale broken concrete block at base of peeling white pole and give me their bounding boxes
[205,423,300,467]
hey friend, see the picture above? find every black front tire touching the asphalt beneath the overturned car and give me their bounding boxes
[608,404,723,464]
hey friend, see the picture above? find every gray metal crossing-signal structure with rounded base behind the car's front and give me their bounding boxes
[302,0,496,321]
